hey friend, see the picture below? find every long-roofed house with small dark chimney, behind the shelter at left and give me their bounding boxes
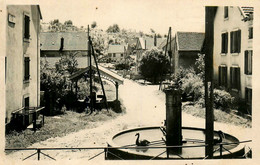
[40,32,89,68]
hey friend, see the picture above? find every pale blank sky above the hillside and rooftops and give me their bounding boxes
[39,0,205,35]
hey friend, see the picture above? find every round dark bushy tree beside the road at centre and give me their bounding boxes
[140,48,170,83]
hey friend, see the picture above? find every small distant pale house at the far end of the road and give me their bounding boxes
[107,44,126,62]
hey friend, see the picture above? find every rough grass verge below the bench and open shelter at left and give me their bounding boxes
[5,110,118,154]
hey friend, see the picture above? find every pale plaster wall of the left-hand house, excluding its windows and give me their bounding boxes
[6,5,40,122]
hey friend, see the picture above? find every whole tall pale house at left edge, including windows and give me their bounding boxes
[5,5,42,127]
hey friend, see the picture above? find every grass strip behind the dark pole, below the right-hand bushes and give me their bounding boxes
[182,103,252,128]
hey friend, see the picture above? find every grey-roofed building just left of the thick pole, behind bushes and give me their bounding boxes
[172,32,204,74]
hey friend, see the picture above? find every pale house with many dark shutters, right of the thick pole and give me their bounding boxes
[213,6,253,113]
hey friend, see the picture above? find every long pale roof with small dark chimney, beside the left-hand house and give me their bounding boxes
[40,32,88,51]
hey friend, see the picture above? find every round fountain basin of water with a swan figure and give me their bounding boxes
[106,127,244,160]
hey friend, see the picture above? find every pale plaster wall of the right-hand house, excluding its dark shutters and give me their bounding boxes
[213,6,252,99]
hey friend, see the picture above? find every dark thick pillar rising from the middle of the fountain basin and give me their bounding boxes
[164,86,182,154]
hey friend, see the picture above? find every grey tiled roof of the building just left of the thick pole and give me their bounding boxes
[176,32,205,51]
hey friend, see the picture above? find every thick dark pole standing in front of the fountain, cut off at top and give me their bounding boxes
[203,7,216,159]
